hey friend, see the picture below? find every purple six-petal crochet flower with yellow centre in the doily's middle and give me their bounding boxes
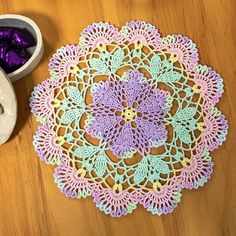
[86,70,169,156]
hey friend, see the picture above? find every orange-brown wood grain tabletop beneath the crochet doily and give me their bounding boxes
[0,0,236,236]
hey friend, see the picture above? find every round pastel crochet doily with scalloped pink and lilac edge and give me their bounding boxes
[30,21,228,217]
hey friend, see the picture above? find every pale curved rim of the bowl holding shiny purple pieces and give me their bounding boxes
[0,14,43,82]
